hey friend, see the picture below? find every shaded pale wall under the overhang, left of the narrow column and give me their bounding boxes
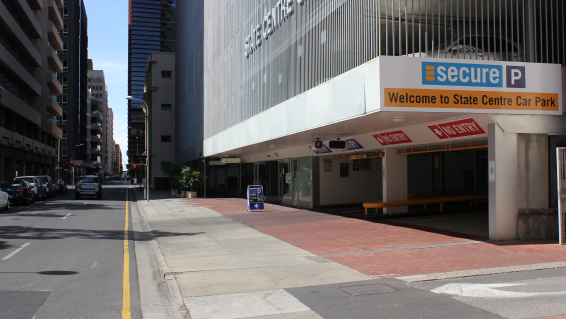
[319,156,383,206]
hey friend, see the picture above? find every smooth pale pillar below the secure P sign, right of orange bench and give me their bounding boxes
[488,124,518,240]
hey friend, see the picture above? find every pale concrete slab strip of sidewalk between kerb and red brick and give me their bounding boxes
[135,189,371,319]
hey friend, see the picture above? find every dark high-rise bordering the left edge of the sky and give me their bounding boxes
[56,0,88,181]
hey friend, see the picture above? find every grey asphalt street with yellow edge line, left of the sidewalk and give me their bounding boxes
[0,181,141,319]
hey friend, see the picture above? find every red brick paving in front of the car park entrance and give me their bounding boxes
[187,199,566,277]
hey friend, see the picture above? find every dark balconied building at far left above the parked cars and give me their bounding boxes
[0,0,66,180]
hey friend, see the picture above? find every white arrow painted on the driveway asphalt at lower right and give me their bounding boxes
[431,284,566,298]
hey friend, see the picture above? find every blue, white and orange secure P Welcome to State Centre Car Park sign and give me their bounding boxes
[379,57,562,115]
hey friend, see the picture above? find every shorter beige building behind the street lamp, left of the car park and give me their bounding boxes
[143,52,175,189]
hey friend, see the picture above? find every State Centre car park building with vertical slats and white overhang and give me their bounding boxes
[175,0,566,240]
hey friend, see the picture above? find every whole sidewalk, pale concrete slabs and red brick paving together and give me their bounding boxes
[136,189,566,319]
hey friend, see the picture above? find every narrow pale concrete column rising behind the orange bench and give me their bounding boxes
[381,149,408,214]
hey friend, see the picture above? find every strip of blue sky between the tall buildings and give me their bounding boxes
[84,0,128,165]
